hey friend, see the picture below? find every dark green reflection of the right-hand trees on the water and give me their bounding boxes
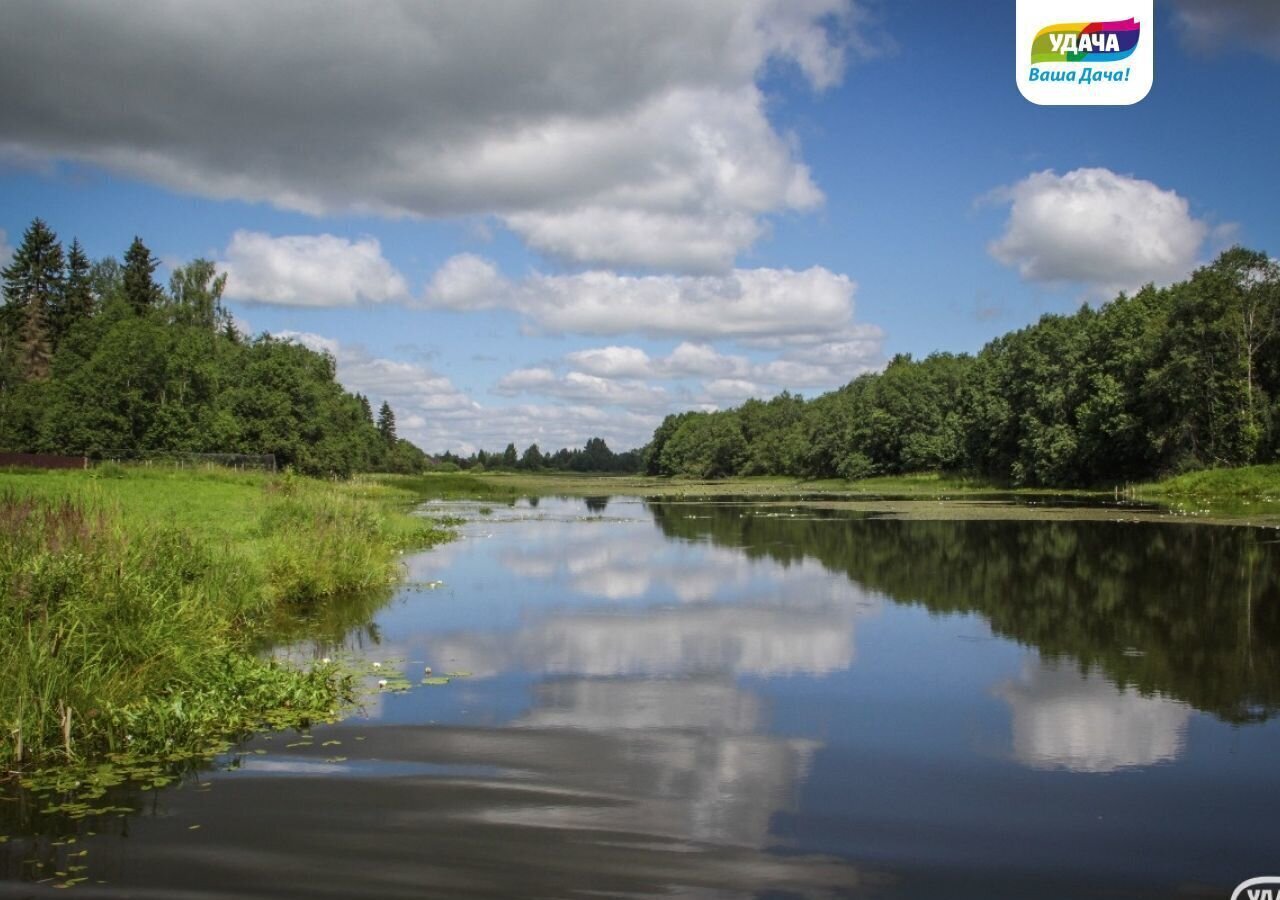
[650,502,1280,722]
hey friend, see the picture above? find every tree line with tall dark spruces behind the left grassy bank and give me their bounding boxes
[0,219,426,476]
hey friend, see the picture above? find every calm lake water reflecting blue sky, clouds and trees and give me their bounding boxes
[0,498,1280,900]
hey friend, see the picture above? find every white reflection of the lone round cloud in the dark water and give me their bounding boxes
[997,663,1190,772]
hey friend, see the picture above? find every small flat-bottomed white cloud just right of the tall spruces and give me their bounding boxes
[218,230,408,306]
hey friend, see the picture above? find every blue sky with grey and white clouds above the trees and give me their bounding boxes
[0,0,1280,453]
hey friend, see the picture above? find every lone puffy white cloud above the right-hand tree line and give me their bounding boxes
[988,169,1210,292]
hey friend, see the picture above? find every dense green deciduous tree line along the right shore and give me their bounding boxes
[644,247,1280,486]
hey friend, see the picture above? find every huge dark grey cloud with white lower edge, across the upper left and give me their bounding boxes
[0,0,873,271]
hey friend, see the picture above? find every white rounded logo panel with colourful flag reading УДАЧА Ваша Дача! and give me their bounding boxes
[1014,0,1157,106]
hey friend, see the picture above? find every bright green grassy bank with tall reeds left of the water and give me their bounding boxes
[0,466,444,771]
